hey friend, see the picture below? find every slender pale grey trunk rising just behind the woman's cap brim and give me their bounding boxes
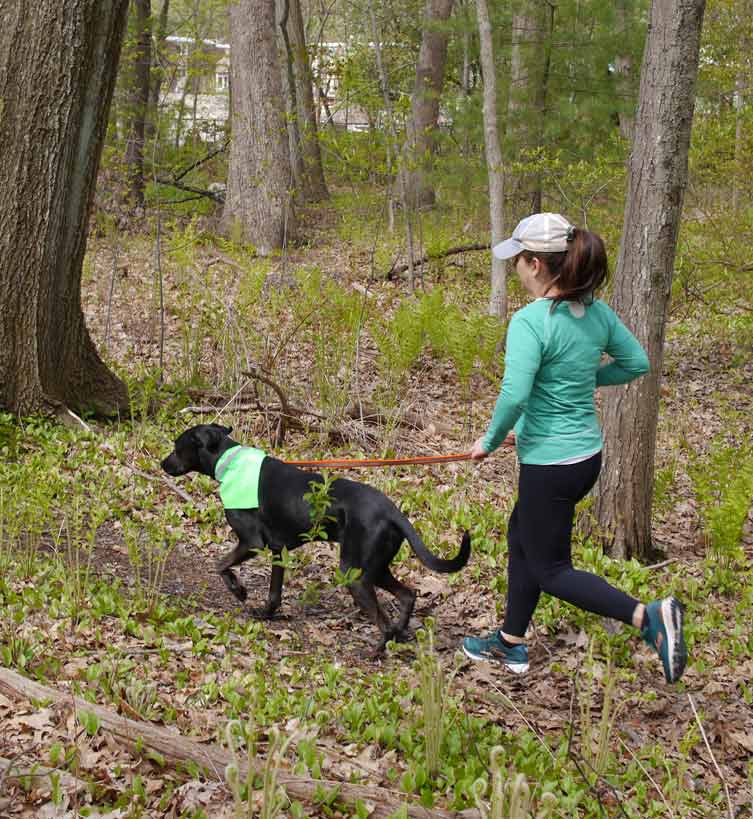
[476,0,507,321]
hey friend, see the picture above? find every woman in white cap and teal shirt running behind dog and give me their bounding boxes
[463,213,687,682]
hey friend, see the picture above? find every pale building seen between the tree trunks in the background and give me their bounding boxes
[160,36,369,143]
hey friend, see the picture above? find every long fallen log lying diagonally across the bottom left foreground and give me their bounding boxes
[0,668,480,819]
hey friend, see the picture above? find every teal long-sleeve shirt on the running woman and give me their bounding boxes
[483,299,649,464]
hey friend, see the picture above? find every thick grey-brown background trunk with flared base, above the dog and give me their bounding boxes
[222,0,295,255]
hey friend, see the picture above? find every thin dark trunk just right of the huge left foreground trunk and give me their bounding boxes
[125,0,152,207]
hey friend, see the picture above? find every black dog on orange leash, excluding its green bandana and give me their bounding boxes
[162,424,471,651]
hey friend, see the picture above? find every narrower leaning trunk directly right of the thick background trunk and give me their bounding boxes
[288,0,329,202]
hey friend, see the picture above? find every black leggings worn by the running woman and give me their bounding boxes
[502,452,638,637]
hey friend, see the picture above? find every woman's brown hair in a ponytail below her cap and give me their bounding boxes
[521,228,609,309]
